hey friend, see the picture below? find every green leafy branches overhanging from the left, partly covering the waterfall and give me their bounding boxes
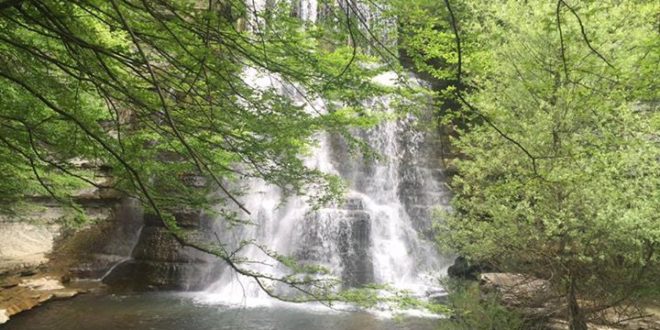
[0,0,400,217]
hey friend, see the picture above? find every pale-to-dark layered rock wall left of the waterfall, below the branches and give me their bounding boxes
[0,165,218,290]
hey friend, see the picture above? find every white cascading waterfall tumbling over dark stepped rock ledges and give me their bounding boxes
[200,0,449,305]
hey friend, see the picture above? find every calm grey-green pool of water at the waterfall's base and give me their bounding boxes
[0,293,440,330]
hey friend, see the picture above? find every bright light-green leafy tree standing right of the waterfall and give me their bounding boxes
[419,1,660,324]
